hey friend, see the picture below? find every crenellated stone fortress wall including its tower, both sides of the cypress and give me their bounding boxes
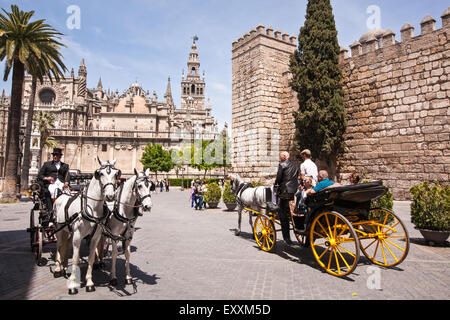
[233,7,450,200]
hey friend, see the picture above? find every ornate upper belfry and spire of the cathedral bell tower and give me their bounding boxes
[181,36,205,110]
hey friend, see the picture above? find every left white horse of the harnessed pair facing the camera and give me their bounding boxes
[54,158,121,294]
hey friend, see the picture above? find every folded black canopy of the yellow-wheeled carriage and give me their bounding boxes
[307,180,388,203]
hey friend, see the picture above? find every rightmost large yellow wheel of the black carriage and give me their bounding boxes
[358,209,409,267]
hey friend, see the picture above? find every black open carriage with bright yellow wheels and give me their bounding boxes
[239,181,410,277]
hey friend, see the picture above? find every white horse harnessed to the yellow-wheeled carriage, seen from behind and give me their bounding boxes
[230,174,267,236]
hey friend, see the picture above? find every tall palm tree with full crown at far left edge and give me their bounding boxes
[0,5,65,201]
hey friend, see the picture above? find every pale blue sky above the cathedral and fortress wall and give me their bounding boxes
[0,0,449,127]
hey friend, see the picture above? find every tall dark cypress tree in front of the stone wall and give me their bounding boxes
[290,0,347,177]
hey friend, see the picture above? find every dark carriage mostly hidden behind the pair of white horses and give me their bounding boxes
[27,174,92,266]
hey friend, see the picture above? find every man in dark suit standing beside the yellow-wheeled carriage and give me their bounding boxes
[275,152,299,245]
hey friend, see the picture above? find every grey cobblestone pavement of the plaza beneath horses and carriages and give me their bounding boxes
[0,190,450,300]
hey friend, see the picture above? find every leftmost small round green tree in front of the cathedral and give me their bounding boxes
[141,142,174,179]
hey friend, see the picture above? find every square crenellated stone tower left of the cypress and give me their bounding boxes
[232,25,297,181]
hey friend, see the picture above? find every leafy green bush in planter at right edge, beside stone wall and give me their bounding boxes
[410,181,450,231]
